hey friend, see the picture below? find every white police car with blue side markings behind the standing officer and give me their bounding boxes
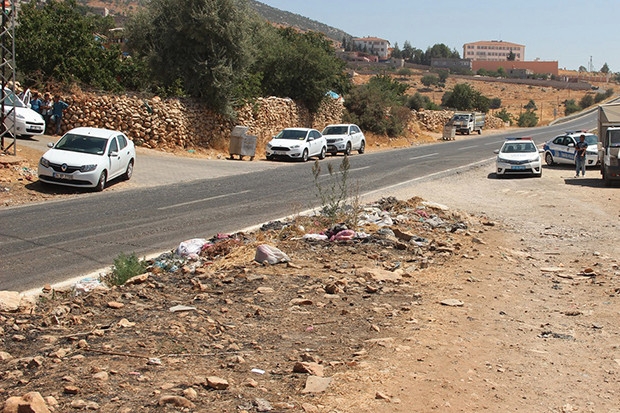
[543,131,599,166]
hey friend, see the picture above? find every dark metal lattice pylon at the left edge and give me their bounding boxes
[0,0,17,155]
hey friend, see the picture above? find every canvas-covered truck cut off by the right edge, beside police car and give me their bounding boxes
[598,103,620,186]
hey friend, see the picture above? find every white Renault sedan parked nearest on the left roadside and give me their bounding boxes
[38,127,136,191]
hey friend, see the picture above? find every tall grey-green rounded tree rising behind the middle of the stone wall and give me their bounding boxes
[128,0,261,113]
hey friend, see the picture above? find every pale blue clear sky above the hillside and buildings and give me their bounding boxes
[258,0,620,72]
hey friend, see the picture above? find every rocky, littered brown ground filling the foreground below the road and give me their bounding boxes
[0,127,620,412]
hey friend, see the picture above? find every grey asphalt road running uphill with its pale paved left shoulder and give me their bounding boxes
[0,114,596,291]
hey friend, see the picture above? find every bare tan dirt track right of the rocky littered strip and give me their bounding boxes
[322,165,620,412]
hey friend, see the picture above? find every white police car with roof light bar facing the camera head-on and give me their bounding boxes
[494,137,542,178]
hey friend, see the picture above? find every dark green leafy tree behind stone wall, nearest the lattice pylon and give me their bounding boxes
[15,0,132,89]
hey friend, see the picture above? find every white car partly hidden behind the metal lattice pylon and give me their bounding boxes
[0,88,45,137]
